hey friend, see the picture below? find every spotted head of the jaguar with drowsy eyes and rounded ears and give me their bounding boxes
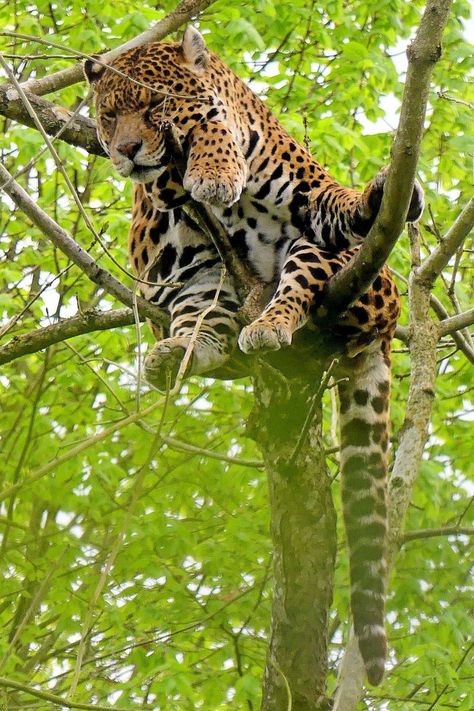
[84,27,225,183]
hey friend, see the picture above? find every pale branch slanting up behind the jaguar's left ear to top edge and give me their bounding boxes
[15,0,213,95]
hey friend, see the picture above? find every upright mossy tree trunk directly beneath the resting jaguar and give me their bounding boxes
[248,350,336,711]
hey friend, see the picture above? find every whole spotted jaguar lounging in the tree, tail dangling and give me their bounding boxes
[85,27,423,685]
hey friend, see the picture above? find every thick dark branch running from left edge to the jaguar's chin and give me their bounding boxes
[0,84,105,156]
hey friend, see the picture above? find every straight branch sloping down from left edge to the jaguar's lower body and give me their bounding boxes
[0,165,169,325]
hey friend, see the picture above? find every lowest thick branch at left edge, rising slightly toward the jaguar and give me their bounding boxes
[0,309,135,365]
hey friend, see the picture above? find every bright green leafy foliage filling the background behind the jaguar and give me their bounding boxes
[0,0,474,711]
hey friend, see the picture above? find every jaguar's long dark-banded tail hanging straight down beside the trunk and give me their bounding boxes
[339,338,390,685]
